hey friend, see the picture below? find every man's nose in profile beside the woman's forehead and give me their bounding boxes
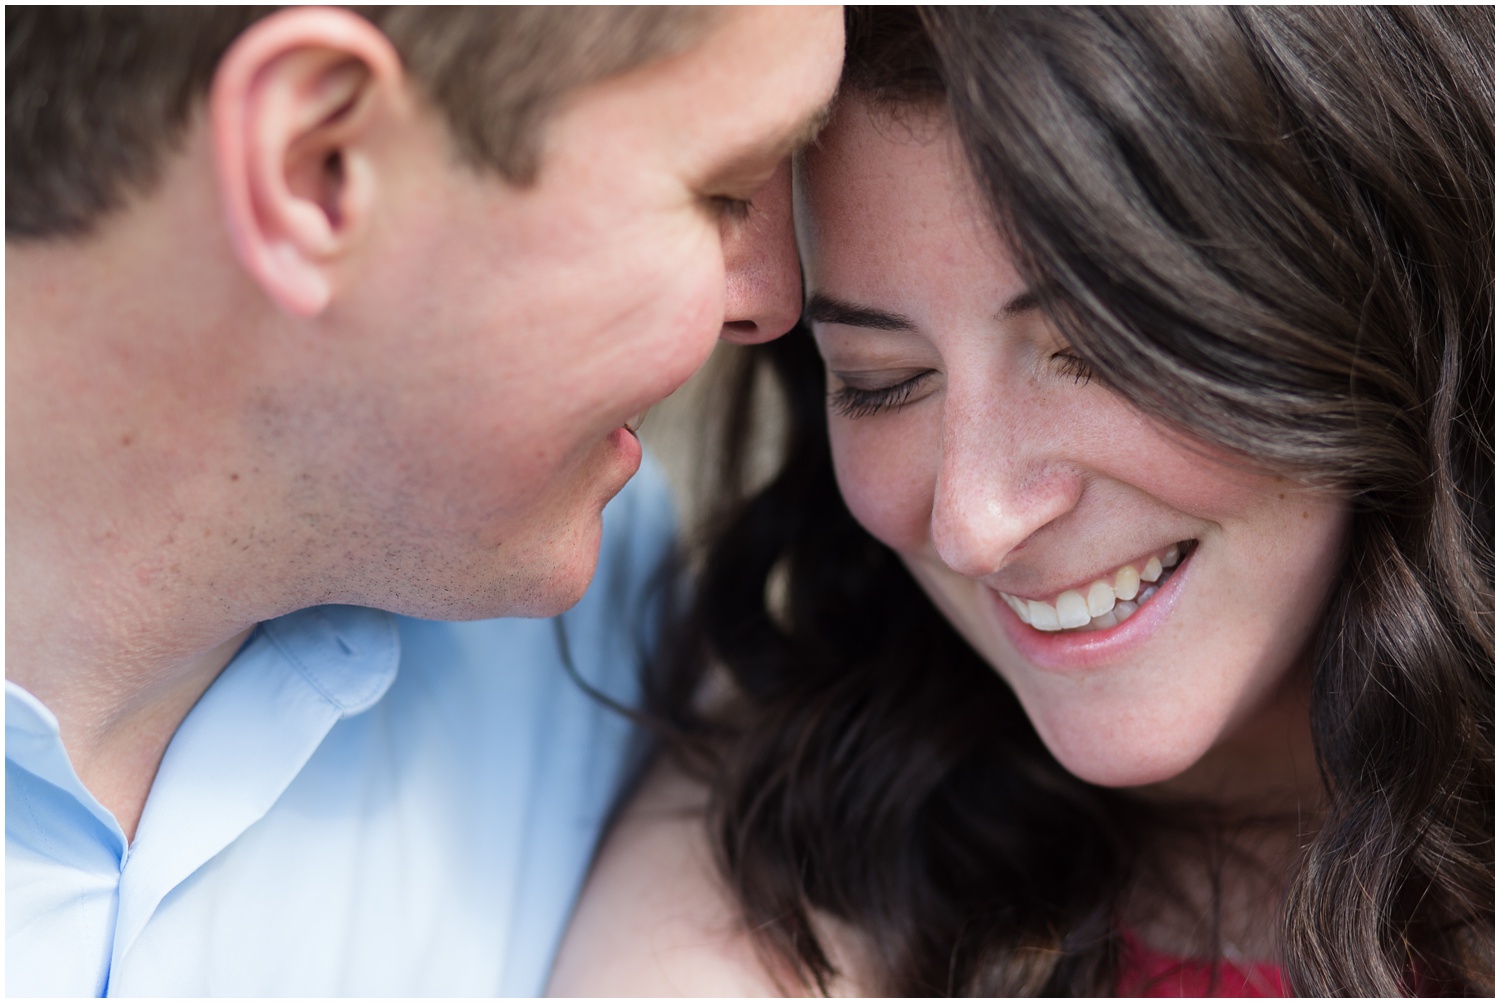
[720,157,803,345]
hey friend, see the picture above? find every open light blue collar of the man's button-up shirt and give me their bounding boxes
[6,606,401,960]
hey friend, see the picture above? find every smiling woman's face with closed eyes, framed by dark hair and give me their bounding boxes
[798,96,1347,786]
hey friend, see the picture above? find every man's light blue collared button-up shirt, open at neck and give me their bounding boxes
[6,466,672,996]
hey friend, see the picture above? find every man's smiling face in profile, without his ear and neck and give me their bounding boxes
[267,7,843,618]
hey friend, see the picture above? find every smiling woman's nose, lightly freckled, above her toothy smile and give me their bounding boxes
[932,391,1083,579]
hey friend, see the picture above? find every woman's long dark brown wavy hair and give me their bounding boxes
[657,7,1496,996]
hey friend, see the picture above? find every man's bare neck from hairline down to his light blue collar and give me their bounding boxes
[6,183,290,837]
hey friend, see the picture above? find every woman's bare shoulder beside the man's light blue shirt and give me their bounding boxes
[548,765,795,996]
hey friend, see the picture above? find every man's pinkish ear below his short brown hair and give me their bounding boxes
[209,7,410,316]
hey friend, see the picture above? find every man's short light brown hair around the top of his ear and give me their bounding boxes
[5,6,711,238]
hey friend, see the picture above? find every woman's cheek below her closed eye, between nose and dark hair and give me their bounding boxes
[828,412,941,553]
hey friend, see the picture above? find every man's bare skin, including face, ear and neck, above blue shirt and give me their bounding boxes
[6,9,843,835]
